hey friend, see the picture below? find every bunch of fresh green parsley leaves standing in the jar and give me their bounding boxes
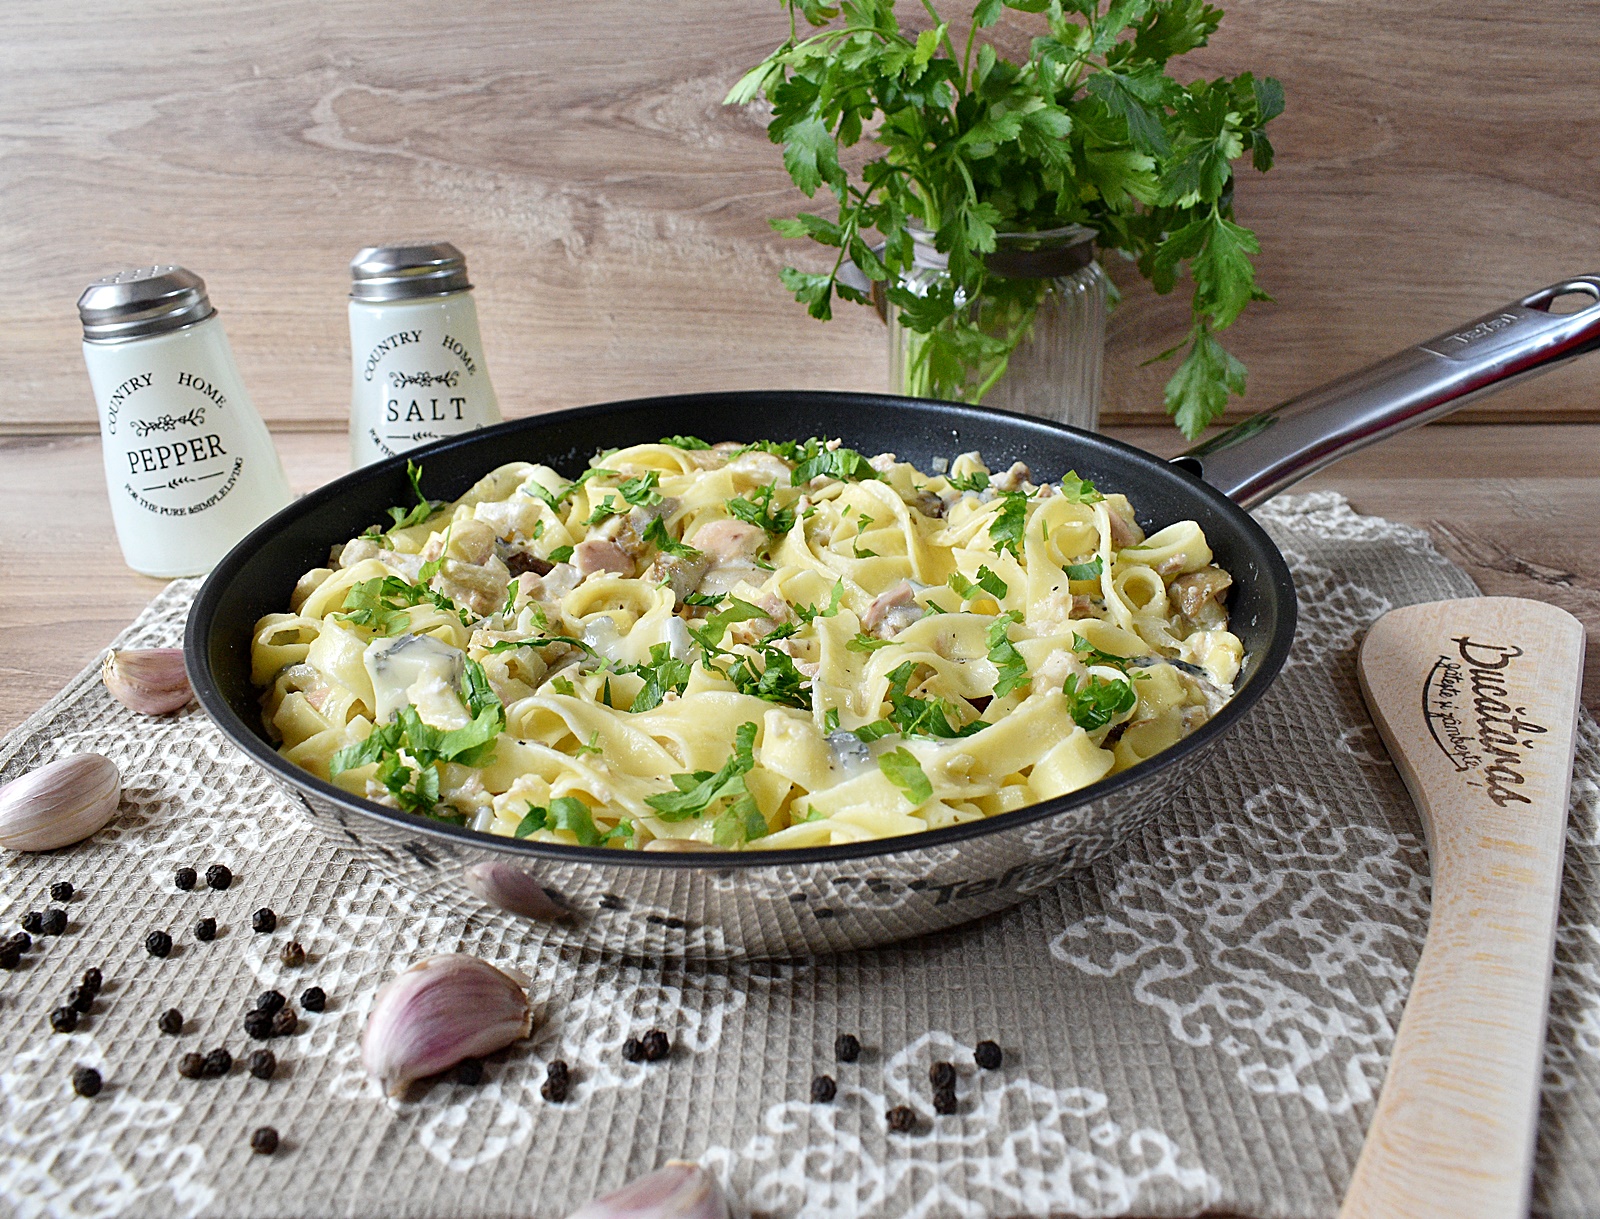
[726,0,1283,437]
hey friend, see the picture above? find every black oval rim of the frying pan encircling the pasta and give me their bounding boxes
[184,390,1296,870]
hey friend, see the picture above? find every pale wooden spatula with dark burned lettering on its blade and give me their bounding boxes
[1339,597,1584,1219]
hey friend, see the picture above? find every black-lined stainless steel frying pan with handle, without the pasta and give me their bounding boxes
[186,275,1600,958]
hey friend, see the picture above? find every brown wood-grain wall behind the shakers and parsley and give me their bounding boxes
[0,0,1600,434]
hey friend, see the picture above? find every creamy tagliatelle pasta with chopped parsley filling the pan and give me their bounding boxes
[251,437,1242,849]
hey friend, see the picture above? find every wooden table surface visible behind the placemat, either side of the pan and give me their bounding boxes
[0,424,1600,733]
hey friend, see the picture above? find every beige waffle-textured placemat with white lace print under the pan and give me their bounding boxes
[0,494,1600,1219]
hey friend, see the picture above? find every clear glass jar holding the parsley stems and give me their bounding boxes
[886,226,1107,430]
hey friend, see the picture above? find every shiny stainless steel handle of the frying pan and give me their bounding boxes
[1173,275,1600,507]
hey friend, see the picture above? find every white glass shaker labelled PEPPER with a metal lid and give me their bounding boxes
[78,266,290,578]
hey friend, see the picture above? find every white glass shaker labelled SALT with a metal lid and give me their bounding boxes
[350,242,501,469]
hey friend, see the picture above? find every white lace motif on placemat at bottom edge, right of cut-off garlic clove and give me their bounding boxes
[701,1032,1221,1219]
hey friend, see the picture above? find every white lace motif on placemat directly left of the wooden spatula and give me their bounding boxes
[1050,785,1427,1113]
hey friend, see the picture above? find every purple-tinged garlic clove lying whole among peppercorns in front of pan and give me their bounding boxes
[362,952,533,1096]
